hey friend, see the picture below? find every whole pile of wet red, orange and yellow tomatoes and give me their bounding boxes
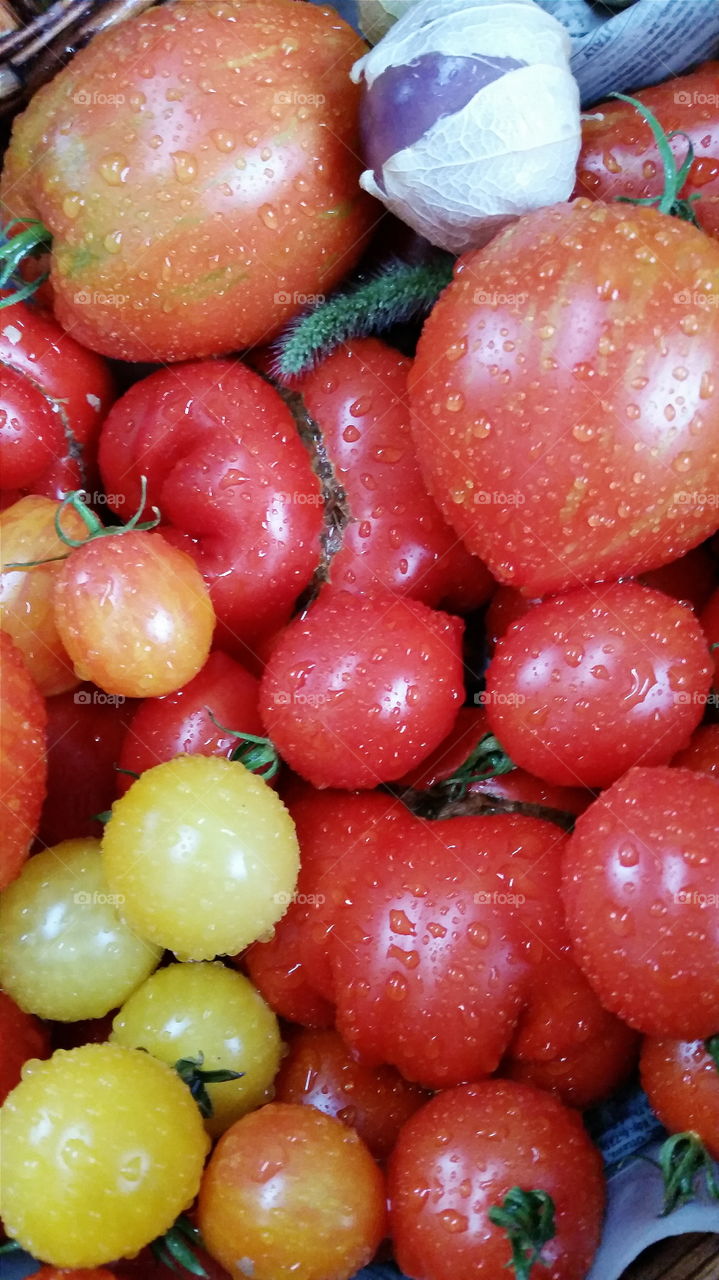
[0,0,719,1280]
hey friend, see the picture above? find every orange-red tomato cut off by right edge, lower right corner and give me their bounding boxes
[640,1037,719,1160]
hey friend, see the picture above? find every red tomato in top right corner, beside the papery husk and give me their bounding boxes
[574,63,719,236]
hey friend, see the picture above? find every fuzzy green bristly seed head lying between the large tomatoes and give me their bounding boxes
[274,253,454,383]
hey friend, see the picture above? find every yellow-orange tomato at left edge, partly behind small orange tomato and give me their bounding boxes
[0,497,87,698]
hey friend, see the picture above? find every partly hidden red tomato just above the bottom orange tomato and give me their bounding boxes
[275,1030,427,1160]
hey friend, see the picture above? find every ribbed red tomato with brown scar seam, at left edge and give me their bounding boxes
[0,302,114,498]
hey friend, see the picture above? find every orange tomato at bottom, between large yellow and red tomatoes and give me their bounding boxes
[198,1102,385,1280]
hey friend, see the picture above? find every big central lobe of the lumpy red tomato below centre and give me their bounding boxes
[330,815,565,1088]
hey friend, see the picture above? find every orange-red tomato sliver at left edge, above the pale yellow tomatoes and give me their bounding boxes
[0,631,47,888]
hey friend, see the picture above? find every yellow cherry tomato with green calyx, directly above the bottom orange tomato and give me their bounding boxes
[110,964,281,1137]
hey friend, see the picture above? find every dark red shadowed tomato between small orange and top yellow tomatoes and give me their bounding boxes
[37,685,137,846]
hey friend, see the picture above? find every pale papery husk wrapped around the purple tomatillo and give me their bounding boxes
[352,0,581,253]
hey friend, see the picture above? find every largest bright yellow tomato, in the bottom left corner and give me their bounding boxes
[0,1044,210,1267]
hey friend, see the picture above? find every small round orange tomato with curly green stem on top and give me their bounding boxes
[52,532,215,698]
